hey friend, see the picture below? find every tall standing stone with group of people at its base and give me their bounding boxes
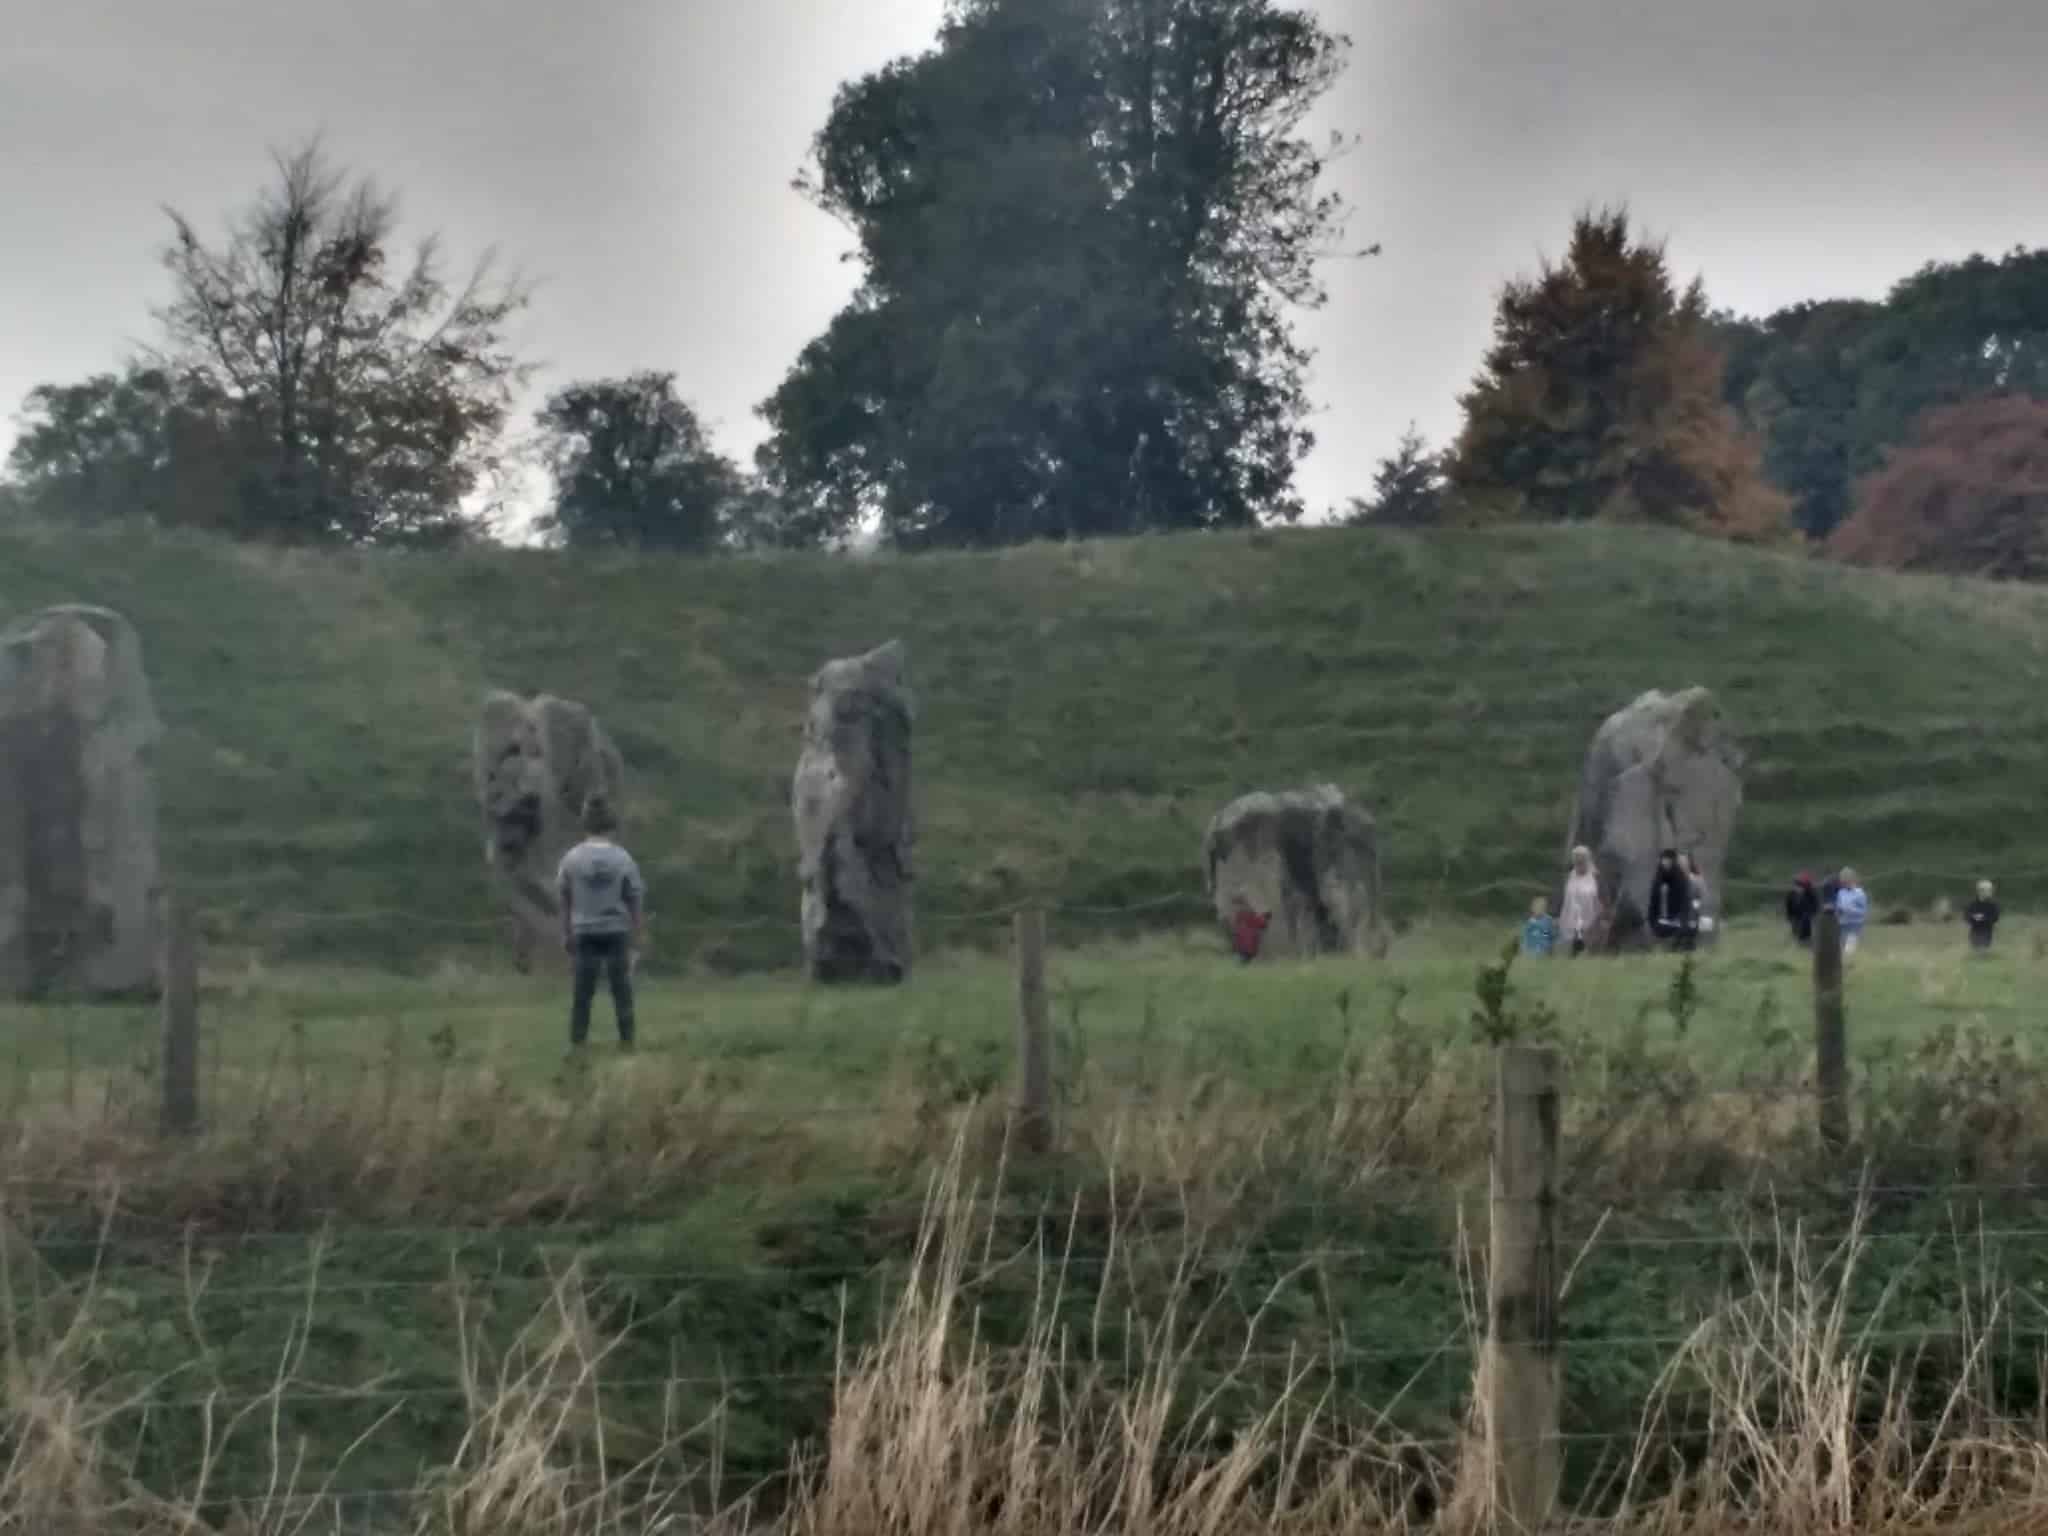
[1565,688,1743,946]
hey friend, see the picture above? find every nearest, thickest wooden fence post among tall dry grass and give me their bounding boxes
[1479,1044,1565,1532]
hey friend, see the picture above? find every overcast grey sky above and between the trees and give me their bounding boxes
[0,0,2048,524]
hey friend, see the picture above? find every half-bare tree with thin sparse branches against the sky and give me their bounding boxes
[160,145,524,543]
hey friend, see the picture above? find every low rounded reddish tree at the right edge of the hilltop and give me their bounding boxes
[1829,395,2048,582]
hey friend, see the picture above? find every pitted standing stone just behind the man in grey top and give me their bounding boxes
[475,690,625,969]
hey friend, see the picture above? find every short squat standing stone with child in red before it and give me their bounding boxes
[1202,784,1384,956]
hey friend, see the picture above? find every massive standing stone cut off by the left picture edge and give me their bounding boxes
[0,606,162,997]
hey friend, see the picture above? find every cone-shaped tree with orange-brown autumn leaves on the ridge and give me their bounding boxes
[1446,209,1790,541]
